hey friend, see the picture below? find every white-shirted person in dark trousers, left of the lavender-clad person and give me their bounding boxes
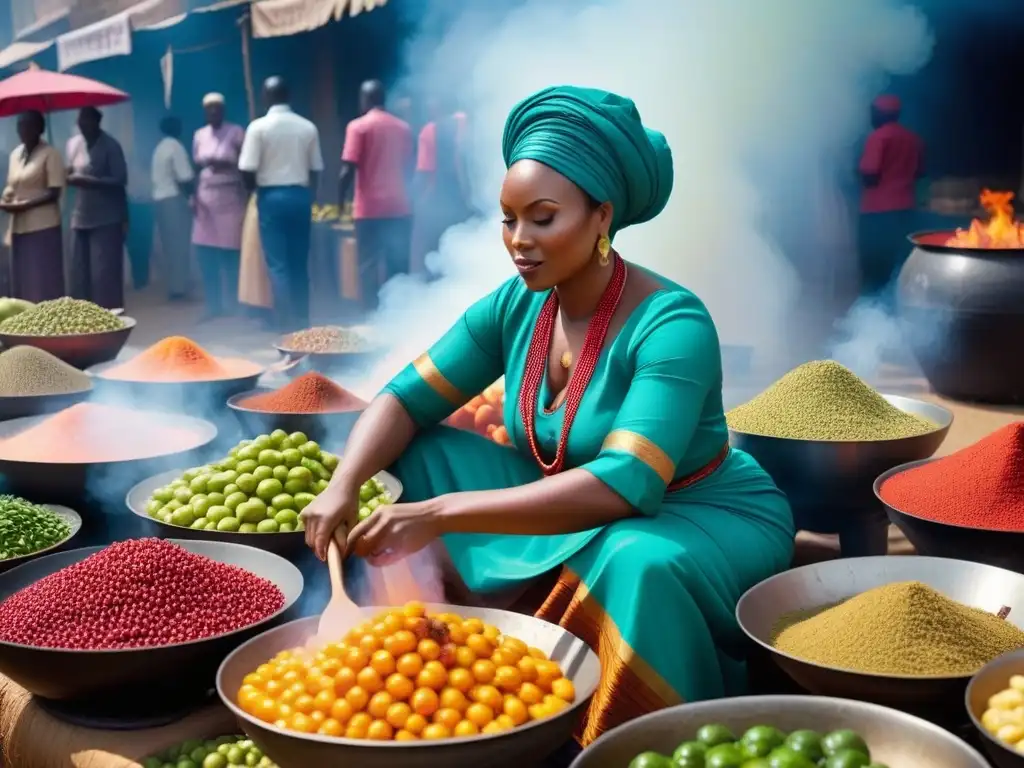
[151,116,196,301]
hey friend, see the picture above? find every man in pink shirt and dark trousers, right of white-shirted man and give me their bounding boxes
[338,80,413,306]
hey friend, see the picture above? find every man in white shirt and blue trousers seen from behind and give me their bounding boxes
[239,77,324,331]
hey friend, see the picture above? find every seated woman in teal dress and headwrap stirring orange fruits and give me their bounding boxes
[303,86,794,743]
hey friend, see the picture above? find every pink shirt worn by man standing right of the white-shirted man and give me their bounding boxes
[341,109,413,219]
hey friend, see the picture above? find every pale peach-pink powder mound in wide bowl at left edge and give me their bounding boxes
[0,402,202,464]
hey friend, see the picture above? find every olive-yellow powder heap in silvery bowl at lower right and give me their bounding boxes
[772,582,1024,677]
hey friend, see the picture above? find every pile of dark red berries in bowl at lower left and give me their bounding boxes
[0,539,285,650]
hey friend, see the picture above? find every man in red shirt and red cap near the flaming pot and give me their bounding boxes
[858,95,925,295]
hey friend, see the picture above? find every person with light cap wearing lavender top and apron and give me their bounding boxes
[193,93,247,319]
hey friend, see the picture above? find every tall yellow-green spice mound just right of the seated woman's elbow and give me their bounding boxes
[725,360,938,440]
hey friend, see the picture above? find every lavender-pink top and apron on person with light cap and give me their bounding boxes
[193,123,249,251]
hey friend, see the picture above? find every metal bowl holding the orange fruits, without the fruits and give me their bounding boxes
[217,605,601,768]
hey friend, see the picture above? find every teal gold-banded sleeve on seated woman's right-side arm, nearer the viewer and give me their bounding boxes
[581,293,722,515]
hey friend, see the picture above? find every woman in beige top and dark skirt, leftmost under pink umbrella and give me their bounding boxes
[0,112,66,302]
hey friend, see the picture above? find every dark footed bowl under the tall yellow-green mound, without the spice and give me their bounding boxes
[729,394,953,557]
